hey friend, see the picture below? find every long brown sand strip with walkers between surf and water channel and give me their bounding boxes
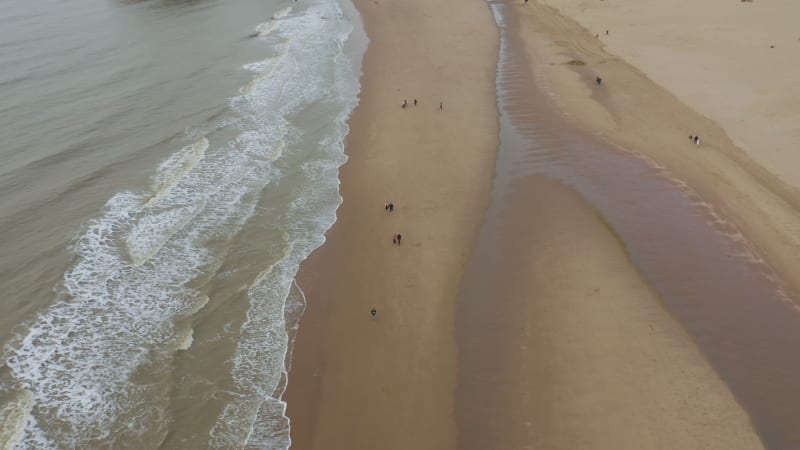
[286,0,498,450]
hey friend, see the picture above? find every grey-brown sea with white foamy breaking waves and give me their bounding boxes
[0,0,367,449]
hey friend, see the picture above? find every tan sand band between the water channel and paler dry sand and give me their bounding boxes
[510,0,800,300]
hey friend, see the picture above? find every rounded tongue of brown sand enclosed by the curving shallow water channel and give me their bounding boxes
[457,177,761,450]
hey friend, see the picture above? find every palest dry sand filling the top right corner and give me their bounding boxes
[542,0,800,188]
